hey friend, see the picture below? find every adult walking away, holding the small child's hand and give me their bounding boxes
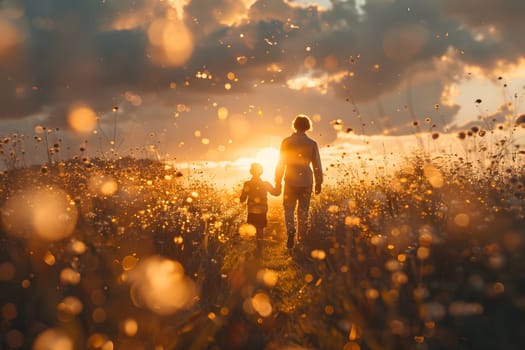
[275,114,323,249]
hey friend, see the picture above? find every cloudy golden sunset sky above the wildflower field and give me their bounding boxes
[0,0,525,175]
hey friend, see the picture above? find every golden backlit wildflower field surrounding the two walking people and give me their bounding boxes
[0,122,525,350]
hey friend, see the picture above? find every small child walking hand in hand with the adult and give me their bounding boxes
[240,163,281,240]
